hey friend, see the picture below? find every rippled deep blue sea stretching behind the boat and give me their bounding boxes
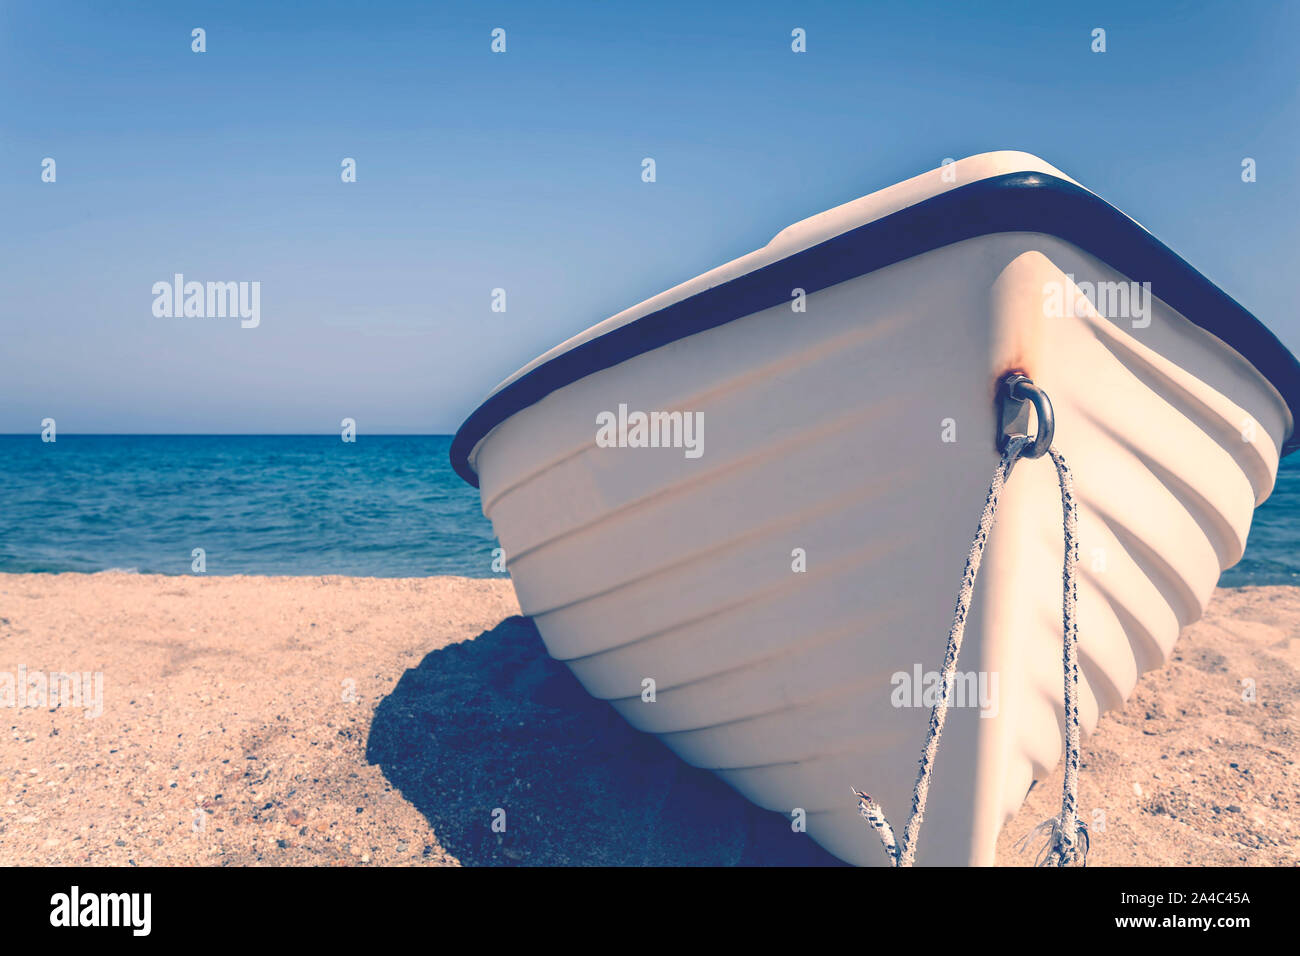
[0,434,1300,587]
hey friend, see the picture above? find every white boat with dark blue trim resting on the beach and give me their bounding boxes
[451,152,1300,865]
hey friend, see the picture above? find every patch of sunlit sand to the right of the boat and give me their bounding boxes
[997,588,1300,866]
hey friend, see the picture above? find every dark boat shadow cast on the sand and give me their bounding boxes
[367,617,837,866]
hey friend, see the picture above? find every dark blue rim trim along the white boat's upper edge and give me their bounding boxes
[451,173,1300,488]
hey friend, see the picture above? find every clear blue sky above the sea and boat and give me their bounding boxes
[0,0,1300,433]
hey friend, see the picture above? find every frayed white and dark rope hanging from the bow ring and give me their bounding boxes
[853,437,1088,866]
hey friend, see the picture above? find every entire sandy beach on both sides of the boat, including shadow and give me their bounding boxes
[0,572,1300,866]
